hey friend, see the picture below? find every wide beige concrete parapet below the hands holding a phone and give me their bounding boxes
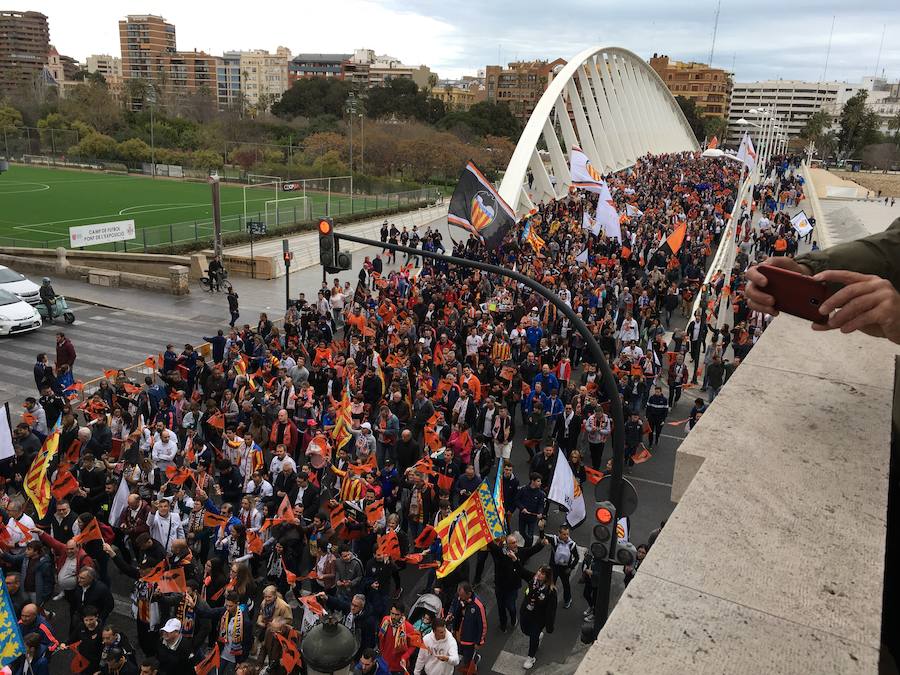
[578,315,900,675]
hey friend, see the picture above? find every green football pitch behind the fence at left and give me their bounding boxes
[0,165,376,249]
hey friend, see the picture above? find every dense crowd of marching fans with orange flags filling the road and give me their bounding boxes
[0,153,802,675]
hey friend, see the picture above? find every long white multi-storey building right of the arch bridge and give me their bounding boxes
[726,80,841,147]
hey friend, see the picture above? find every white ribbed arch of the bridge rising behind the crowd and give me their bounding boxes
[499,47,699,216]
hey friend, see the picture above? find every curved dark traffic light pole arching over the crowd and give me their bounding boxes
[334,231,625,637]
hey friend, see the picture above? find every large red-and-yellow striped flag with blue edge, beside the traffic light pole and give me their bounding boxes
[437,481,504,578]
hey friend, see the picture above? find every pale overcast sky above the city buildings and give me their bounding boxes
[20,0,900,82]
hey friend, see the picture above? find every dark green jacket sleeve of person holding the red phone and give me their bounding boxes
[797,218,900,291]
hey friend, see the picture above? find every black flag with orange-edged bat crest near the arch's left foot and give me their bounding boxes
[447,162,516,249]
